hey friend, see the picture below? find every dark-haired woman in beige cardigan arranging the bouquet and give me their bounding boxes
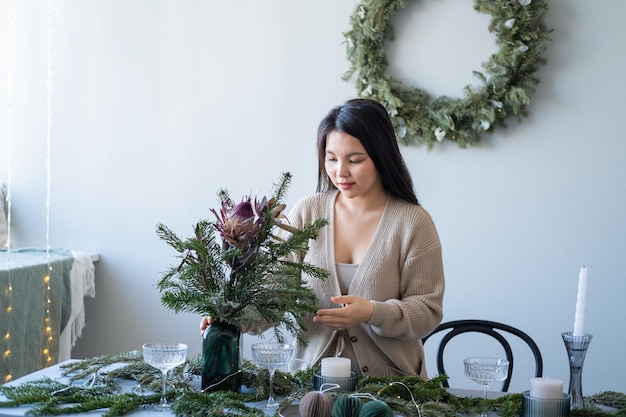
[201,99,445,379]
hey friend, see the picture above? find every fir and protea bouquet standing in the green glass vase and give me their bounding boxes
[157,173,328,343]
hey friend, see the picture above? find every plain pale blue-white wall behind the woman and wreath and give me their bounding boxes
[0,0,626,394]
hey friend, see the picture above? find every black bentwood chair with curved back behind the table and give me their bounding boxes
[422,320,543,392]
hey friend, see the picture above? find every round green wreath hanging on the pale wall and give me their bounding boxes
[343,0,551,149]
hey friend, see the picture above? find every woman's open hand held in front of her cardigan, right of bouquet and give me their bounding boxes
[313,295,374,330]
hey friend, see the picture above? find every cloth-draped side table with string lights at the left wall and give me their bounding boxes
[0,248,95,383]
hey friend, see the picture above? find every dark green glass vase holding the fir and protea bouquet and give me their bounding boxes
[202,322,241,392]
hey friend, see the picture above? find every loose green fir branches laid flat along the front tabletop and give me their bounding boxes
[0,352,626,417]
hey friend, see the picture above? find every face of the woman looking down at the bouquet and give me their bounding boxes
[325,130,382,198]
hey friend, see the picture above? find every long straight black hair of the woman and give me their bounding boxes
[317,98,419,205]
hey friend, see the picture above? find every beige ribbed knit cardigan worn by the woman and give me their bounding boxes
[288,190,445,379]
